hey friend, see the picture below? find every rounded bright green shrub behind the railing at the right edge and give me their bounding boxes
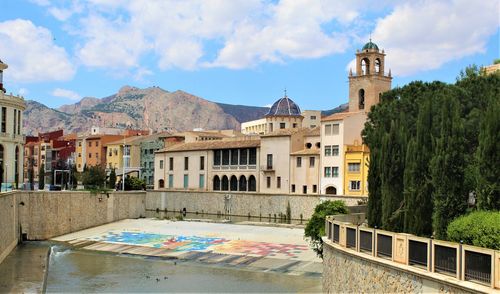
[447,211,500,250]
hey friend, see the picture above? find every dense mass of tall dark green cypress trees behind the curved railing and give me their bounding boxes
[363,67,500,239]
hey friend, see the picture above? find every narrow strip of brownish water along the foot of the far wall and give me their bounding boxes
[146,210,307,225]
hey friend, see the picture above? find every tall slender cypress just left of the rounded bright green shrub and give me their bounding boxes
[431,94,467,239]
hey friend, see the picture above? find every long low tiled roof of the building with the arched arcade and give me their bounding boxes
[159,139,260,153]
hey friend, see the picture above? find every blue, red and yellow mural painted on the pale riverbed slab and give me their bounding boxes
[90,231,308,258]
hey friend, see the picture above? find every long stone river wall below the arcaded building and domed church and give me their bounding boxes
[146,191,365,220]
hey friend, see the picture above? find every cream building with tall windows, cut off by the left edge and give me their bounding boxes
[0,60,26,191]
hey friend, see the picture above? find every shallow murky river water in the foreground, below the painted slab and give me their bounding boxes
[47,246,321,293]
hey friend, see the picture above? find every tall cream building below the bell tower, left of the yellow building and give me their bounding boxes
[321,111,366,195]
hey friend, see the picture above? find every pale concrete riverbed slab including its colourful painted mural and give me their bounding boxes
[53,219,322,275]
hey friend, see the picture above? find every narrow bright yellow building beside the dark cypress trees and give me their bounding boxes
[344,145,370,196]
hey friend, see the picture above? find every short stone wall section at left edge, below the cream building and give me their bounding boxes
[0,192,19,263]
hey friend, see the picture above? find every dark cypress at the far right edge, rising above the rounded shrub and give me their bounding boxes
[477,99,500,210]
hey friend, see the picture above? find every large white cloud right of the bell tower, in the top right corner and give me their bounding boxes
[373,0,499,76]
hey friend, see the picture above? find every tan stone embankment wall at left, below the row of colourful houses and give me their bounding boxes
[15,192,146,240]
